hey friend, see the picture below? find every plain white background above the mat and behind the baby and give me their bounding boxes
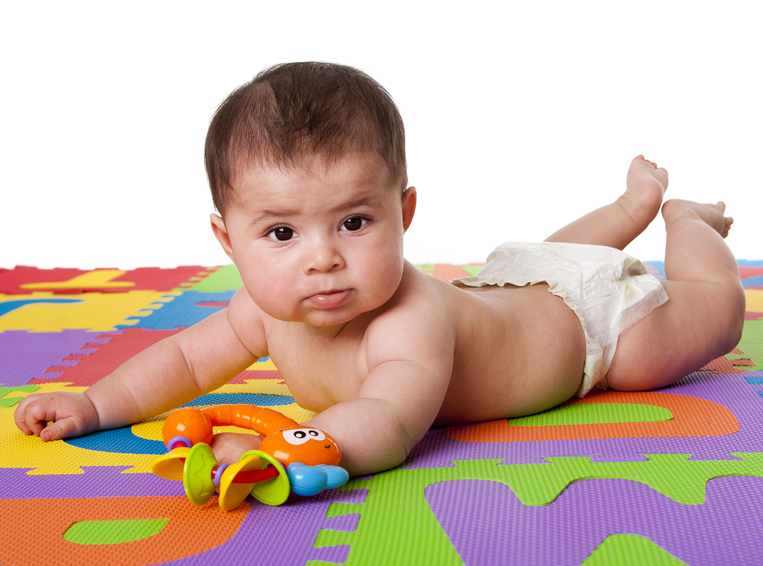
[0,0,763,268]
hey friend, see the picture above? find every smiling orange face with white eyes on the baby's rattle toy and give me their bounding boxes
[260,427,342,466]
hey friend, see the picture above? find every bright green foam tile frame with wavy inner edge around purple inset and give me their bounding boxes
[309,454,763,566]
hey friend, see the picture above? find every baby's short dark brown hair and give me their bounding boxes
[204,62,408,215]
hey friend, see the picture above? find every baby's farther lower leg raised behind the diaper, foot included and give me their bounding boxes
[546,155,668,250]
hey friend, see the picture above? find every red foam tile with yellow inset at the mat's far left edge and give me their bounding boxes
[0,265,217,295]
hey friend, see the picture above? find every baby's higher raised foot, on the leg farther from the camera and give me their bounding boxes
[617,155,668,230]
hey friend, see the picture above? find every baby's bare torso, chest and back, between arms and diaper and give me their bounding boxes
[265,264,585,425]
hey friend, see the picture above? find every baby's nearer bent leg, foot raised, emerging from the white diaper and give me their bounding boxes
[606,200,745,391]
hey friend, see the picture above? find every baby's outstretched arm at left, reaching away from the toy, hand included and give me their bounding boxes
[15,292,266,441]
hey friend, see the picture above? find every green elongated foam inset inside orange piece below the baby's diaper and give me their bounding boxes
[508,403,673,426]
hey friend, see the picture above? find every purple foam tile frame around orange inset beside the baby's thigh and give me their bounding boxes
[406,371,763,468]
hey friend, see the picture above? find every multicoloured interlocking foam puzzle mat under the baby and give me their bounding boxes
[0,260,763,566]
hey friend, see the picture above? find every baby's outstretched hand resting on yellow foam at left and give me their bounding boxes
[14,391,98,442]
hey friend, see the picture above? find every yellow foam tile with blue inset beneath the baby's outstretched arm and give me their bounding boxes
[0,380,315,475]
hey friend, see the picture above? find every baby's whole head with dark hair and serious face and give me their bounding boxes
[205,63,416,326]
